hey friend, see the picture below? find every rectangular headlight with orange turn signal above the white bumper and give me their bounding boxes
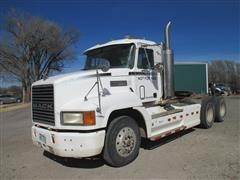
[61,111,95,126]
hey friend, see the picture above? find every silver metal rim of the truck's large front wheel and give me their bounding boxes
[116,127,137,157]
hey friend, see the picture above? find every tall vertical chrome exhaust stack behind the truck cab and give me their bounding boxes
[163,21,175,99]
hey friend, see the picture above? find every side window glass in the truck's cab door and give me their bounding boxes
[137,48,154,69]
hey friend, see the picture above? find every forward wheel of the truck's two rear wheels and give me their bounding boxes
[200,97,215,129]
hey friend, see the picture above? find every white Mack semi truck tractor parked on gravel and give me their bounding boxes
[32,22,226,167]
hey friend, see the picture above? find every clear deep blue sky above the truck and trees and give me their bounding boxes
[0,0,240,71]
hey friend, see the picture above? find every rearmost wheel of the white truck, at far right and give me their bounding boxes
[215,97,227,122]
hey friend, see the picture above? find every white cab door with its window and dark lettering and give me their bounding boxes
[135,48,160,102]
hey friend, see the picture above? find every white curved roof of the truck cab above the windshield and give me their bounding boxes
[84,38,156,53]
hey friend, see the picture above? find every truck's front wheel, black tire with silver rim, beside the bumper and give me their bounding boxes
[103,116,141,167]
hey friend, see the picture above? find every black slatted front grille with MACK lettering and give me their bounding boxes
[32,84,55,125]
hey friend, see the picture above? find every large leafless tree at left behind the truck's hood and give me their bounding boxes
[0,11,79,102]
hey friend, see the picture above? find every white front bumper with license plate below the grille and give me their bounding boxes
[32,126,105,158]
